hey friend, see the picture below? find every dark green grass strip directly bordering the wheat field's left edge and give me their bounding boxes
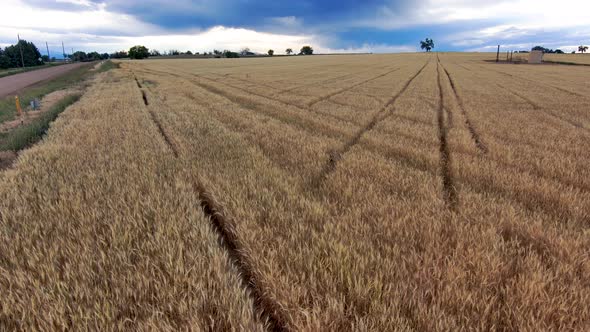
[0,95,81,151]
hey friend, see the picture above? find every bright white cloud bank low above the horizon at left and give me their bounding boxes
[0,0,414,55]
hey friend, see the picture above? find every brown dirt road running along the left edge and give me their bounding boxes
[0,62,87,98]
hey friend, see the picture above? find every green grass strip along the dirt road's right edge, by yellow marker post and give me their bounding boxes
[0,63,93,123]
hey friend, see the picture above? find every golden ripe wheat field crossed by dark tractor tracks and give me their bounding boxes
[0,53,590,331]
